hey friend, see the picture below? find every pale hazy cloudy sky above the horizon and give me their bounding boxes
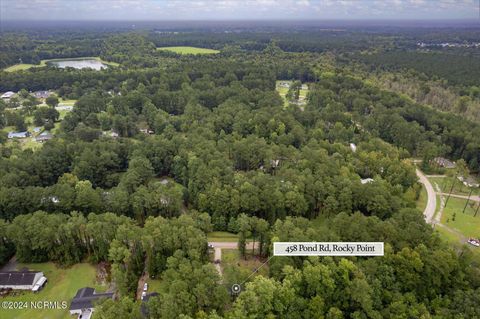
[0,0,479,20]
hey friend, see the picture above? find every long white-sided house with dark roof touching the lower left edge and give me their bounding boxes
[0,269,47,291]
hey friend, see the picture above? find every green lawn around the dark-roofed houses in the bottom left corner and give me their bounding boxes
[0,263,107,319]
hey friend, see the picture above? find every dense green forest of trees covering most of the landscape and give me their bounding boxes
[0,24,480,319]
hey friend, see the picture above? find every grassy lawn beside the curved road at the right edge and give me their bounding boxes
[441,197,480,238]
